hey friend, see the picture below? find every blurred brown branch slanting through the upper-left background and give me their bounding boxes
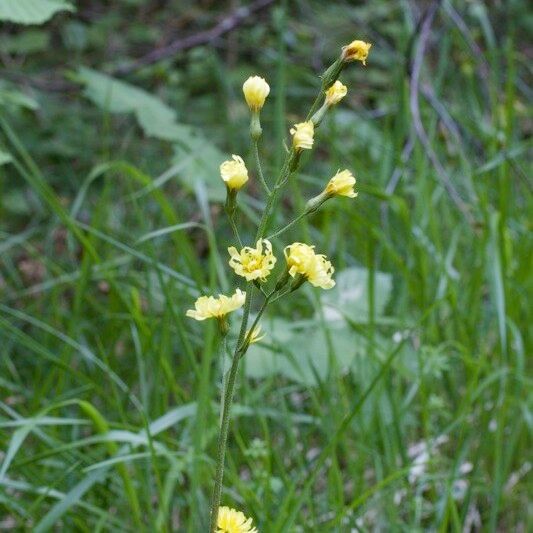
[114,0,275,74]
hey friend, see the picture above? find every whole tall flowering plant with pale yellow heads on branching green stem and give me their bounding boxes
[187,40,371,533]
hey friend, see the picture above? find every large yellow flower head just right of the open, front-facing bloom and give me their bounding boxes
[284,242,335,289]
